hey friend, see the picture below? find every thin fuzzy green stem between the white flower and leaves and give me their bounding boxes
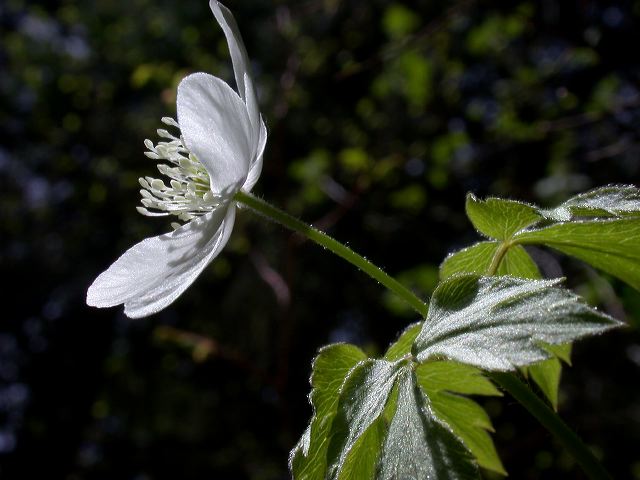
[234,191,427,317]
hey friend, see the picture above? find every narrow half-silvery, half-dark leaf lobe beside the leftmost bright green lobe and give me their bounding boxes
[327,359,401,479]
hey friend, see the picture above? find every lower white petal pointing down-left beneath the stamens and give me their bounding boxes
[87,204,235,318]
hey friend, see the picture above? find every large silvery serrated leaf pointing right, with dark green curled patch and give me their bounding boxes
[413,275,619,371]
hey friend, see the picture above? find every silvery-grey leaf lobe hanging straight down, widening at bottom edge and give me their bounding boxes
[376,366,479,480]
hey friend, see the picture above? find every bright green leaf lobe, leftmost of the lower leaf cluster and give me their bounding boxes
[289,344,367,480]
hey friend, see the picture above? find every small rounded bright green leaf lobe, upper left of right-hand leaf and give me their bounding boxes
[466,193,542,240]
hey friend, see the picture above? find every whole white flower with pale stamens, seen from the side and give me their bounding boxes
[87,0,267,318]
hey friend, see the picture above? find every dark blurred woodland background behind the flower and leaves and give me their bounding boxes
[0,0,640,480]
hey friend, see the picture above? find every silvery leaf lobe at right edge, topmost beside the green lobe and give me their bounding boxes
[542,185,640,222]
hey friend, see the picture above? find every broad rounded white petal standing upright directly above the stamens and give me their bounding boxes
[177,73,254,195]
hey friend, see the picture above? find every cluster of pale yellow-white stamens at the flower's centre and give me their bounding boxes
[137,117,221,228]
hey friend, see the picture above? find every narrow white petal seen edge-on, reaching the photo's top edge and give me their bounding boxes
[209,0,260,131]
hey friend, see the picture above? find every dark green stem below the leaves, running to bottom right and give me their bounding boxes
[488,372,611,480]
